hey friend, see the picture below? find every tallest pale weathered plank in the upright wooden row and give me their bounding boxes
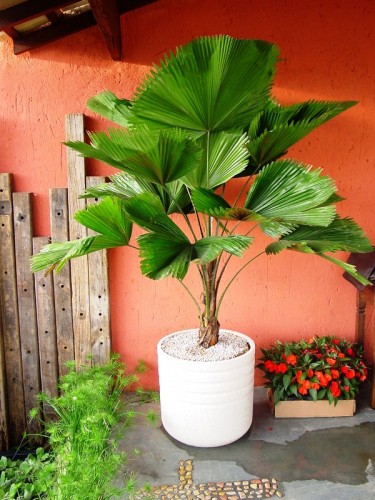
[66,114,91,367]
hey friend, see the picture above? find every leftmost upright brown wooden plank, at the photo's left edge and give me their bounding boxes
[0,174,26,444]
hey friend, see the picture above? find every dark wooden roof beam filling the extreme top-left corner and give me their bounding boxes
[0,0,73,31]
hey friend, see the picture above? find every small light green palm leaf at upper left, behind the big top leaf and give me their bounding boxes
[86,90,131,127]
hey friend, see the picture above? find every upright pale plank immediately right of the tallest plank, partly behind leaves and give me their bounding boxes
[86,177,111,364]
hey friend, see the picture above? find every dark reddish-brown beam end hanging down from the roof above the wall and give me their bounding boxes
[89,0,122,61]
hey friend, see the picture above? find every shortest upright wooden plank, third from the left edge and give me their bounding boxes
[33,236,58,402]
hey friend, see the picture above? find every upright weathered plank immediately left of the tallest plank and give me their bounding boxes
[49,188,74,376]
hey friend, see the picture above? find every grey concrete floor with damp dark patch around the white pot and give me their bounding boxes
[119,388,375,500]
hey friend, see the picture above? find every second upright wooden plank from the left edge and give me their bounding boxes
[13,193,41,433]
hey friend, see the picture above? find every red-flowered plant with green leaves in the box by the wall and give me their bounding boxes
[257,336,367,404]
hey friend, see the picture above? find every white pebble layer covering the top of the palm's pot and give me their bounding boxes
[161,330,250,361]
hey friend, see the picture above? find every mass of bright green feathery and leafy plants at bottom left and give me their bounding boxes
[0,356,158,500]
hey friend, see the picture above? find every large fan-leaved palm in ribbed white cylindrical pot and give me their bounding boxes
[32,36,372,446]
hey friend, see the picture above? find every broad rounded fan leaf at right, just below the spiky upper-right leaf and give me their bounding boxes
[245,160,336,226]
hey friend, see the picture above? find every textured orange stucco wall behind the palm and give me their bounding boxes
[0,0,375,387]
